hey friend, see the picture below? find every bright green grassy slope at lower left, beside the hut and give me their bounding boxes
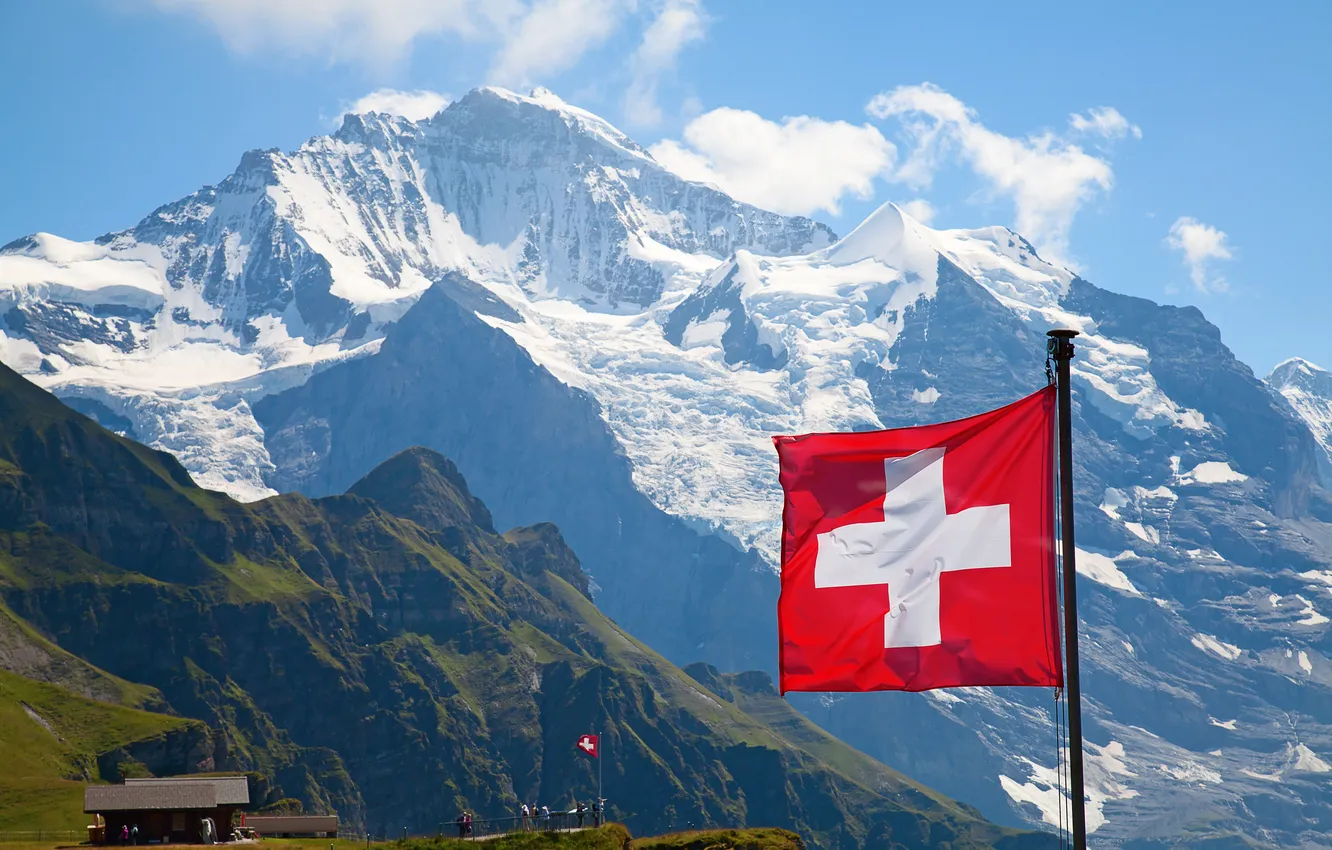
[0,671,201,830]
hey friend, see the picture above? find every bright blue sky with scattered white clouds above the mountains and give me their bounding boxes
[0,0,1332,374]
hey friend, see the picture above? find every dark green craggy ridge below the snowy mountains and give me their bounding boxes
[0,366,1048,850]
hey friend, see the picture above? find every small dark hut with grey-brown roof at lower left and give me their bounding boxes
[84,777,249,845]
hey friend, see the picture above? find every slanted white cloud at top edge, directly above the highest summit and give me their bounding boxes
[488,0,634,85]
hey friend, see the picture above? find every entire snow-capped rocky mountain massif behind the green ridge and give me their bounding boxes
[0,89,1332,846]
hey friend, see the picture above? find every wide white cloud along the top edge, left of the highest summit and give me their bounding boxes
[151,0,500,63]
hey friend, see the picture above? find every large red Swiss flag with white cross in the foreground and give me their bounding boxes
[774,386,1063,693]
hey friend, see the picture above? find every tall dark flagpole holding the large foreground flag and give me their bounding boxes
[1047,328,1087,850]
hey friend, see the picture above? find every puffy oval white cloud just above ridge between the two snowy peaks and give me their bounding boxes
[650,108,896,214]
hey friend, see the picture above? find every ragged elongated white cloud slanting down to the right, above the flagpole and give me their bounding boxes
[866,83,1127,262]
